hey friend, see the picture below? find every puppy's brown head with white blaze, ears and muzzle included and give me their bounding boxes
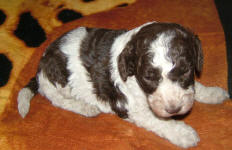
[118,23,203,117]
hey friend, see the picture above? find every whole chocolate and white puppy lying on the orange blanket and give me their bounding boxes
[18,22,228,148]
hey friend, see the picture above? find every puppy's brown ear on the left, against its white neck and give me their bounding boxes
[118,43,136,81]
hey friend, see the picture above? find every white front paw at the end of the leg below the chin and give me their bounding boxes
[167,122,200,148]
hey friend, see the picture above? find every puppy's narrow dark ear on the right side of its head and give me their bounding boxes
[193,35,204,77]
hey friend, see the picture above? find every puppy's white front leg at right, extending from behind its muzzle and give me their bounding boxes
[195,81,229,104]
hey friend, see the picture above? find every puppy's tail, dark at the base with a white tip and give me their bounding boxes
[17,77,39,118]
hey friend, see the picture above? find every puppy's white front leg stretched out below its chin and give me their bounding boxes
[127,108,200,148]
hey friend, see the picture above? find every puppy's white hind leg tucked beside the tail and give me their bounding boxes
[38,73,100,117]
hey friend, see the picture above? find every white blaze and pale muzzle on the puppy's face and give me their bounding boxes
[148,32,194,117]
